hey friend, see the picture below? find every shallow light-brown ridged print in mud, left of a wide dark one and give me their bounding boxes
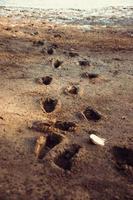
[30,121,53,133]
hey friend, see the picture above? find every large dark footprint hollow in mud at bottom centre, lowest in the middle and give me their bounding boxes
[55,144,81,170]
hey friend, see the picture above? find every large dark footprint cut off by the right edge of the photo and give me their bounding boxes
[112,146,133,178]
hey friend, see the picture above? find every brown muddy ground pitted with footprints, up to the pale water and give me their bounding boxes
[0,9,133,200]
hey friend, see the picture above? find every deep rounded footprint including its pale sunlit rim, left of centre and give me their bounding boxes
[41,98,61,113]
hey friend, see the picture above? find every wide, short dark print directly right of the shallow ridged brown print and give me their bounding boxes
[55,121,76,132]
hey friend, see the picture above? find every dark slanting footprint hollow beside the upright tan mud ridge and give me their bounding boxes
[38,133,63,159]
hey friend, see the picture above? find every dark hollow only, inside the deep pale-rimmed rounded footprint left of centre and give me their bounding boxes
[43,98,58,113]
